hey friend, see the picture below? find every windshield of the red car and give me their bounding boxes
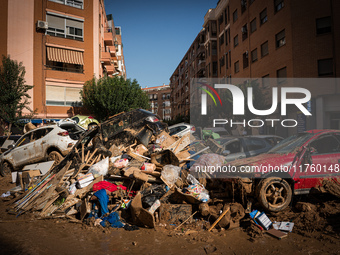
[268,133,313,154]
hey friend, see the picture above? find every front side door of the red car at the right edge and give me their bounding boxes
[298,134,340,189]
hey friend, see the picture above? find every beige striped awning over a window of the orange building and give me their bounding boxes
[47,46,84,65]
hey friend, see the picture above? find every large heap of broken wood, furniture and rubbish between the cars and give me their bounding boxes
[1,110,244,229]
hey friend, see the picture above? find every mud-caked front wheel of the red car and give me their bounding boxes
[257,177,292,212]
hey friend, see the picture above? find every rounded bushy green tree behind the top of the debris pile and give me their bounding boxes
[80,77,149,121]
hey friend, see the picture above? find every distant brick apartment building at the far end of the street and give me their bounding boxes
[142,84,171,120]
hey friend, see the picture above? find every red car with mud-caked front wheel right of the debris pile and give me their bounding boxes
[223,130,340,212]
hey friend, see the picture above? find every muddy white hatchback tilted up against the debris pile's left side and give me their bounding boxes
[0,125,78,176]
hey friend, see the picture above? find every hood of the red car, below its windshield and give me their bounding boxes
[230,153,296,166]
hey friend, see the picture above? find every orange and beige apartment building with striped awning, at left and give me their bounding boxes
[0,0,125,122]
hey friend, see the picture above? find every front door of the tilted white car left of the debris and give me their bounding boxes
[10,132,35,167]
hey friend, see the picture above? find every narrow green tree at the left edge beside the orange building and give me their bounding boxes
[0,56,35,132]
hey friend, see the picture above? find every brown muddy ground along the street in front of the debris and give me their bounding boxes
[0,177,340,255]
